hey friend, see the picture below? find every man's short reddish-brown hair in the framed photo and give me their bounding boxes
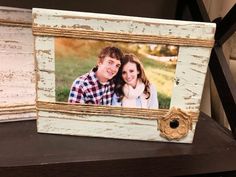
[98,46,123,62]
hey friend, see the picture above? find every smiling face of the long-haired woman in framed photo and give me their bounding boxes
[122,62,139,88]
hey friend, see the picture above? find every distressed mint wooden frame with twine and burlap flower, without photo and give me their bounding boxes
[32,8,215,143]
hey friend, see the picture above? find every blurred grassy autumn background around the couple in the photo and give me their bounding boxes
[55,38,178,109]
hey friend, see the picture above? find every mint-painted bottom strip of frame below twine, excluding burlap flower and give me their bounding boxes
[37,111,196,143]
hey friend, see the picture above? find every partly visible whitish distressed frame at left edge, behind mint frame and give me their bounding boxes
[0,7,36,122]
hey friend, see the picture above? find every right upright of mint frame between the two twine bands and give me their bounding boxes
[170,47,211,112]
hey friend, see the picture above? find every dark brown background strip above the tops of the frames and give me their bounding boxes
[0,0,177,19]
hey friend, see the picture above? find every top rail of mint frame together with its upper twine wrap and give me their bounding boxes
[33,8,215,47]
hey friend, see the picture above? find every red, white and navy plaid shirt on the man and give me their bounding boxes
[68,68,115,105]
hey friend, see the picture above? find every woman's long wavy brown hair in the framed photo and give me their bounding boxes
[115,54,150,102]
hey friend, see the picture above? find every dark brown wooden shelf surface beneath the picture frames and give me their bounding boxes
[0,113,236,177]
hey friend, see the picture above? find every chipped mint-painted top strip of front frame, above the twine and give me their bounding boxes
[33,8,215,39]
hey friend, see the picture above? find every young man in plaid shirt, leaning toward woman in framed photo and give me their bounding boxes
[68,46,123,105]
